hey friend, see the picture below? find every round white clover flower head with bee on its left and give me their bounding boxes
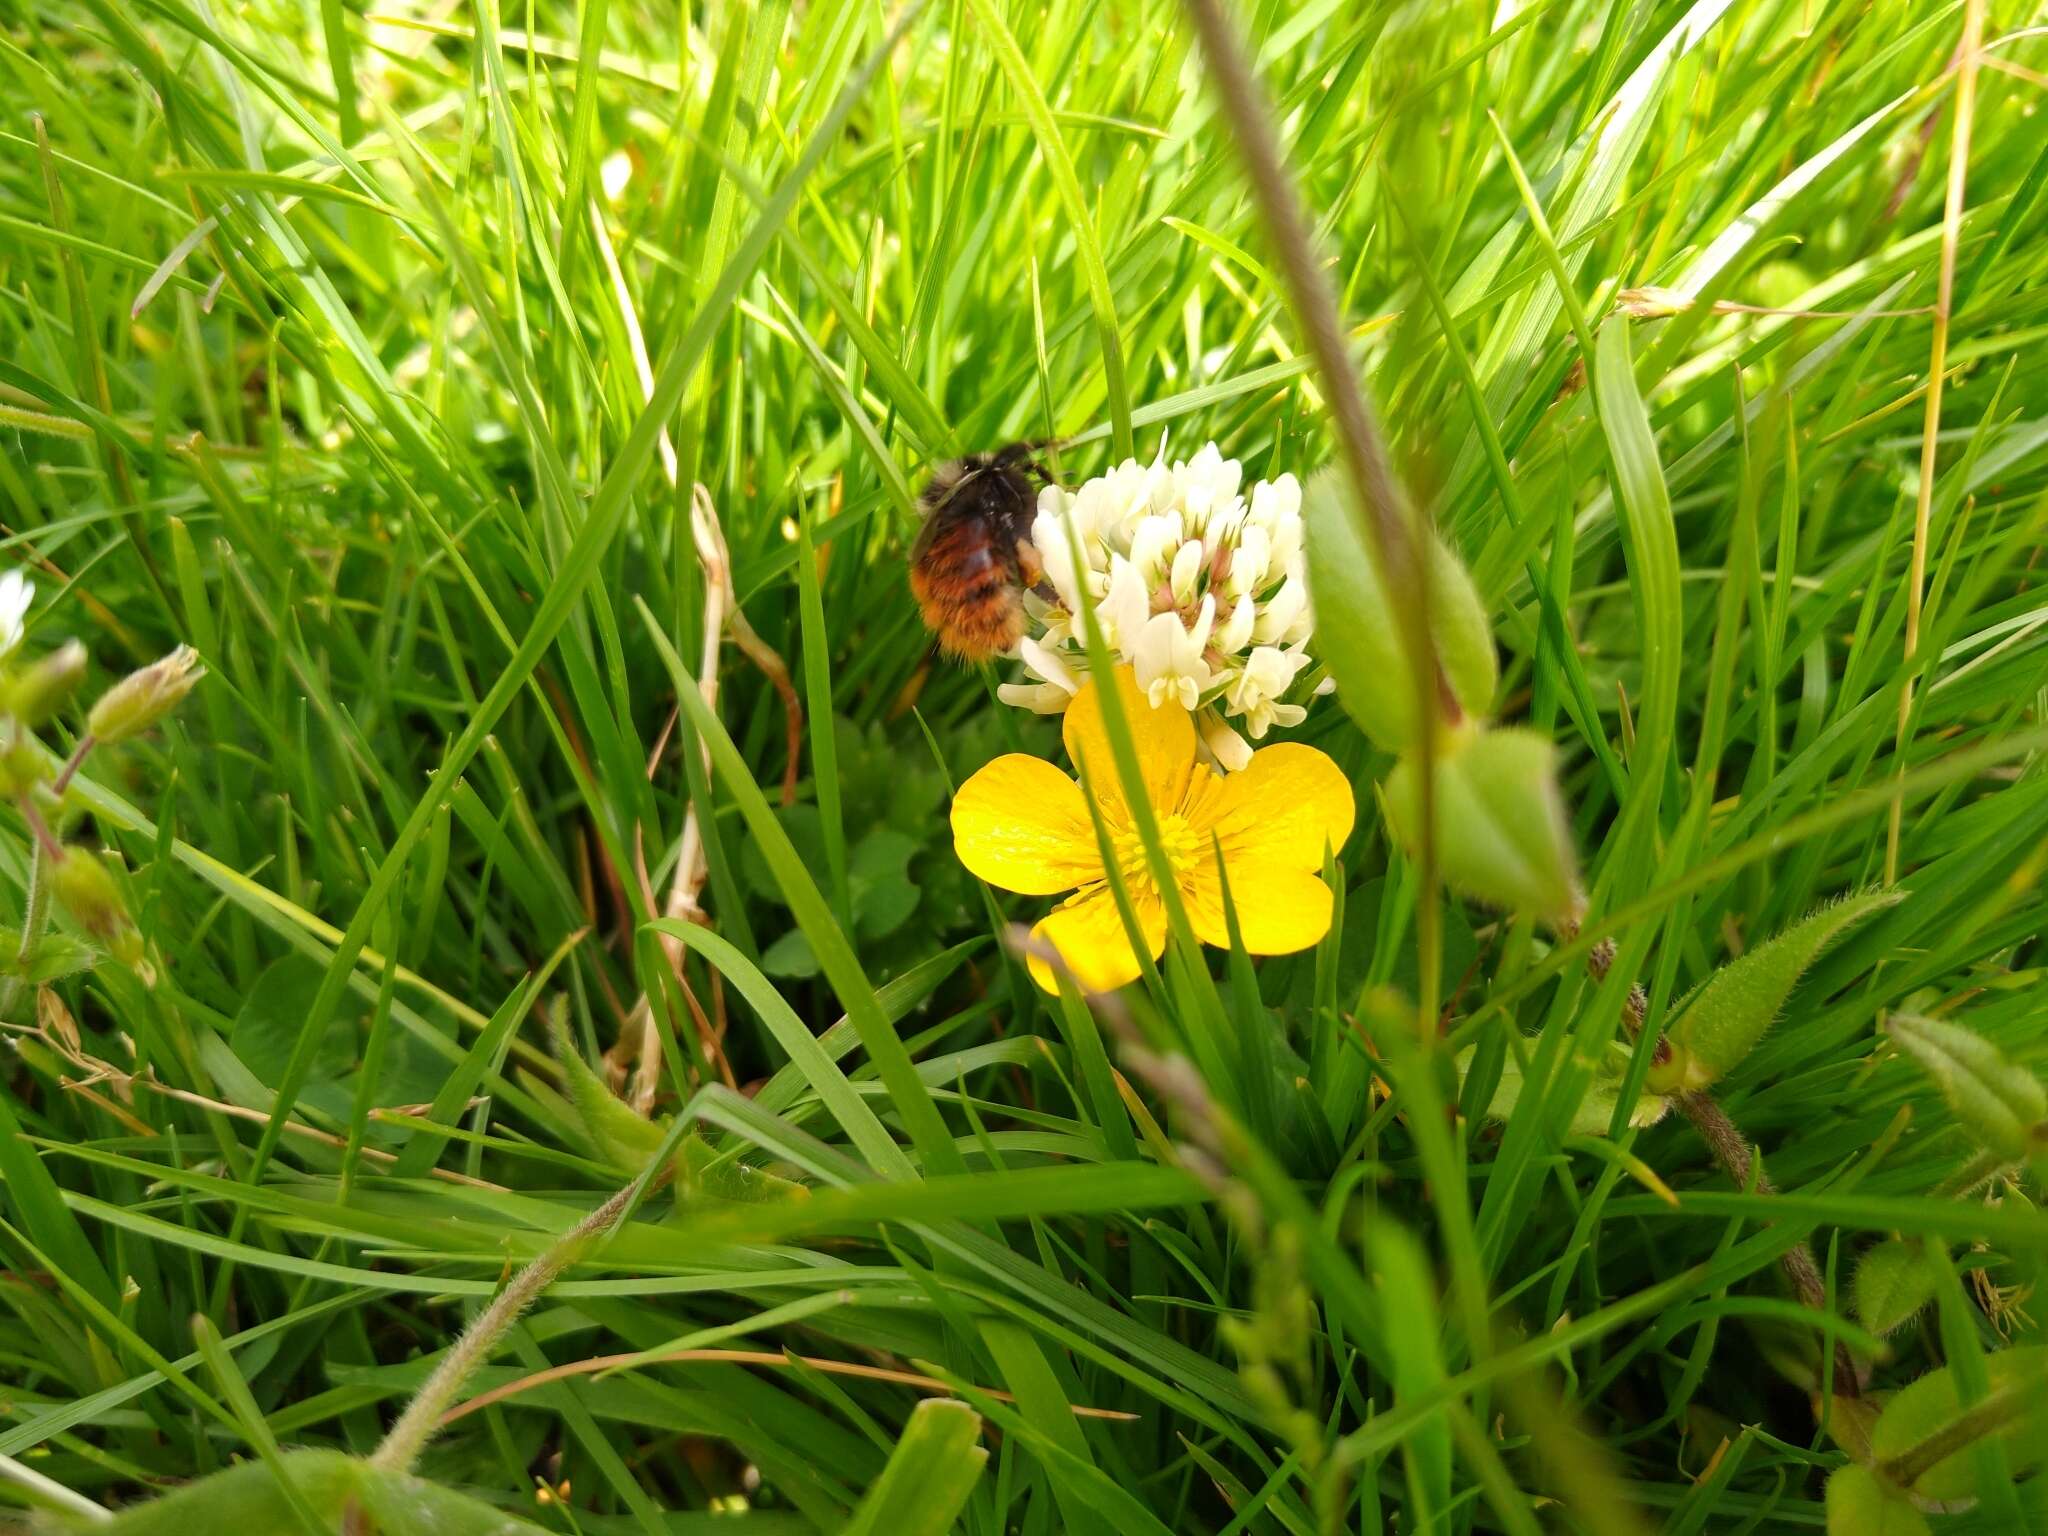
[997,442,1315,770]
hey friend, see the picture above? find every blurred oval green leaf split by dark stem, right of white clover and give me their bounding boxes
[1300,469,1499,752]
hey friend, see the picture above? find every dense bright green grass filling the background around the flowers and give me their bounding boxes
[0,0,2048,1536]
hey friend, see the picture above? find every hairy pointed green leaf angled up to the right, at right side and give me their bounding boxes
[1649,891,1903,1094]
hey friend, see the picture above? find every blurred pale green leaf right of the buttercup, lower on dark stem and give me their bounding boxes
[1386,729,1579,920]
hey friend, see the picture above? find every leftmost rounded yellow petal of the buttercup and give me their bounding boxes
[952,752,1102,895]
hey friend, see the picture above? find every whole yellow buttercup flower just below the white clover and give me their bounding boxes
[952,668,1356,991]
